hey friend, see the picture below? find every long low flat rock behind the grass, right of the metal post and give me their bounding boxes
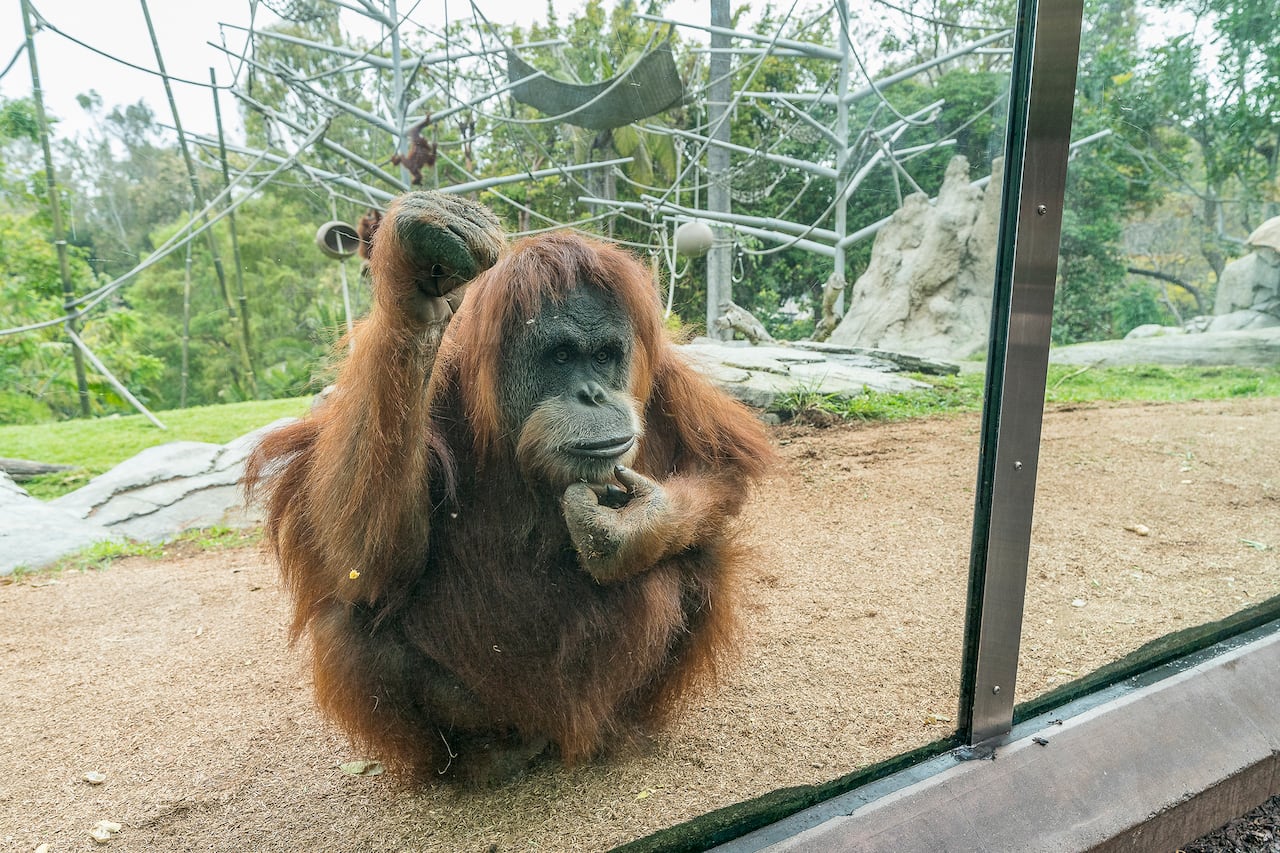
[1048,327,1280,366]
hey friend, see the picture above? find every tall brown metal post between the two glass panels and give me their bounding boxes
[959,0,1083,744]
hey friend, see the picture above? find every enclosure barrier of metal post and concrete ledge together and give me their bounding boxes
[620,0,1280,853]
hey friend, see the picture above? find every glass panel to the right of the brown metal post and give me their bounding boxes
[1018,1,1280,699]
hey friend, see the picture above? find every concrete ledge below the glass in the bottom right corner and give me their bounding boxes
[726,625,1280,853]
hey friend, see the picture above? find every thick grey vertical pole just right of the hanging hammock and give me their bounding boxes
[707,0,733,341]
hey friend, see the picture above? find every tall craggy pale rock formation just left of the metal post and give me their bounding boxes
[829,158,1002,359]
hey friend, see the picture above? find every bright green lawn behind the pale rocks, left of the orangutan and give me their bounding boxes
[0,397,311,500]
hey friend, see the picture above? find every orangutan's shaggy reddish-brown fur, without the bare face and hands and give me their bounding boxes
[246,193,772,779]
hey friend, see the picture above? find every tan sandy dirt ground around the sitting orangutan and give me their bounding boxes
[0,400,1280,853]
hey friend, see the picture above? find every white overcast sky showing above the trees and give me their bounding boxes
[0,0,709,138]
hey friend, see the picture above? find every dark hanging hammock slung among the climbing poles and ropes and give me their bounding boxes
[507,45,685,131]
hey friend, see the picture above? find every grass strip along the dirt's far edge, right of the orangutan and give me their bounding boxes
[773,365,1280,423]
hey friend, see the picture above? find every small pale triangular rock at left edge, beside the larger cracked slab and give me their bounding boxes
[0,474,124,575]
